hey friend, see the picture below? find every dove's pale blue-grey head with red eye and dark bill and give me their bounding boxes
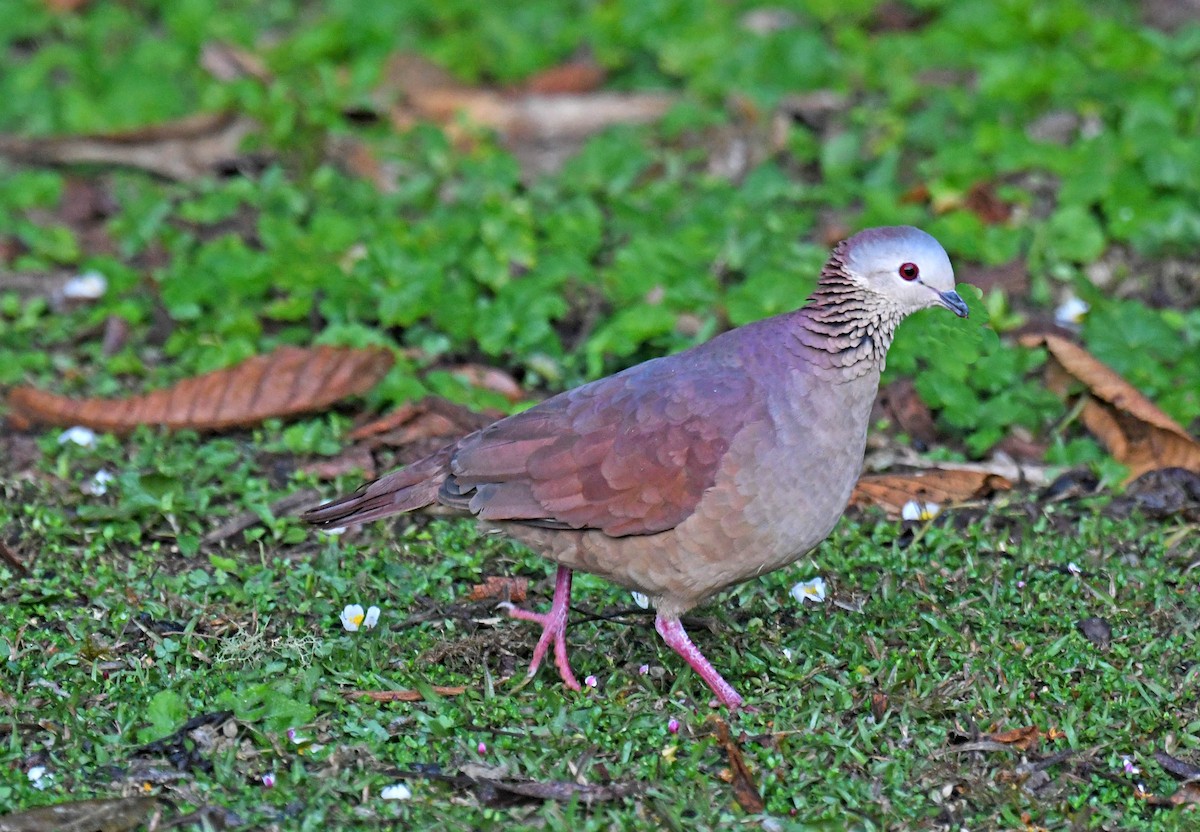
[834,226,968,318]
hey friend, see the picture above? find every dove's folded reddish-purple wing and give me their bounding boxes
[439,355,762,537]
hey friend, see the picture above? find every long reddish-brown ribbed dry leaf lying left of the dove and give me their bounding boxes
[8,347,392,433]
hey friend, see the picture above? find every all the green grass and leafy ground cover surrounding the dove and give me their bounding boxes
[0,0,1200,830]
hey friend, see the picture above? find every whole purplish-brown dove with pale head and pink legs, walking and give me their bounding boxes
[304,226,968,711]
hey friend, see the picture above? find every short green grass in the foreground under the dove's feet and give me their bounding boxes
[0,436,1200,830]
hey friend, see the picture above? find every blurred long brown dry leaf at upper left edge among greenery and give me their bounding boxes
[0,113,254,181]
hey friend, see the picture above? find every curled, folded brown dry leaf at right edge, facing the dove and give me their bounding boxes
[1021,333,1200,481]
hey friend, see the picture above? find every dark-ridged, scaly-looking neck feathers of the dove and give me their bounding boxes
[793,243,900,381]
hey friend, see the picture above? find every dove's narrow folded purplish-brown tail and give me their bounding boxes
[300,444,455,528]
